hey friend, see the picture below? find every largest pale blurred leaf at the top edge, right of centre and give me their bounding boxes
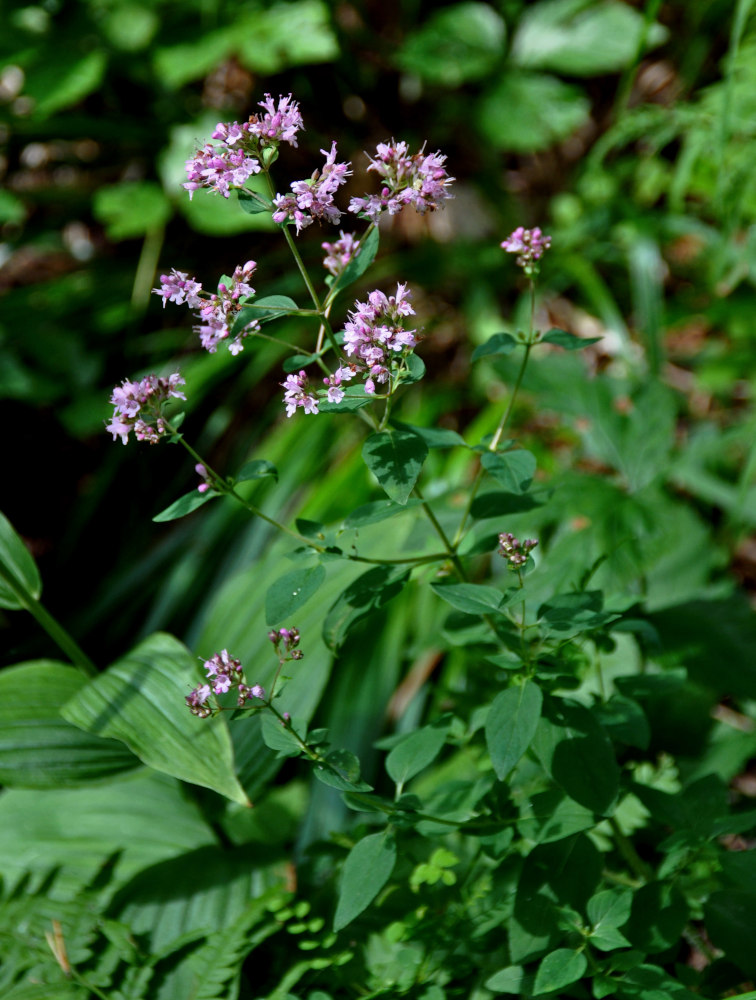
[512,0,667,76]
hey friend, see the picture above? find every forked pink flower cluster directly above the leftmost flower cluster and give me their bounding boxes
[152,260,260,354]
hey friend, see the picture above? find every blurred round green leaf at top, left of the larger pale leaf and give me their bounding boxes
[396,2,506,87]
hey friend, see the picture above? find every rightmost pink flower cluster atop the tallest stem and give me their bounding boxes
[349,139,454,222]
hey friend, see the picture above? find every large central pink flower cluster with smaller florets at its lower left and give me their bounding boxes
[281,284,417,417]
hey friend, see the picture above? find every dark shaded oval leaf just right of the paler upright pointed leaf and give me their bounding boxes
[532,698,619,815]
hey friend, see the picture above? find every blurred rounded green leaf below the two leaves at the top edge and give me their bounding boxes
[477,72,590,153]
